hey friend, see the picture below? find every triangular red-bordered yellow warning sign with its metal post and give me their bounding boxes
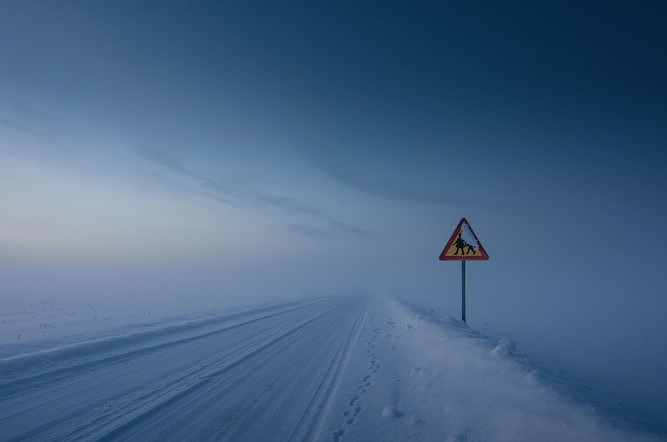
[440,218,489,322]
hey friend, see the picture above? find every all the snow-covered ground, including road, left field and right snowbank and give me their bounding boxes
[0,297,665,441]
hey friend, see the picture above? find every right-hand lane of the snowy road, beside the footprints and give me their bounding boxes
[99,294,368,440]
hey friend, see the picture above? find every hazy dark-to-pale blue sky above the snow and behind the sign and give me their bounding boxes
[0,1,667,332]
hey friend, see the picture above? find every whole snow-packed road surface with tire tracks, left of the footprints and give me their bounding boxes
[0,299,365,440]
